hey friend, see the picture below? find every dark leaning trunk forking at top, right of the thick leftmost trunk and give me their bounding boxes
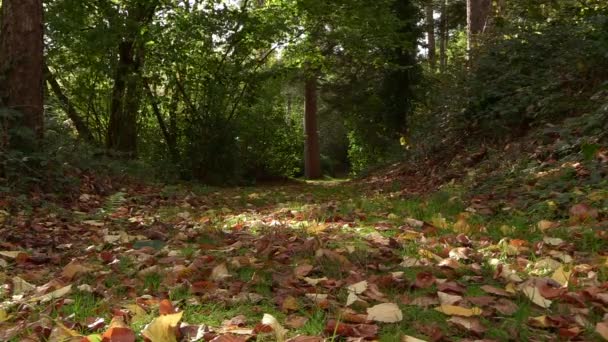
[107,1,158,157]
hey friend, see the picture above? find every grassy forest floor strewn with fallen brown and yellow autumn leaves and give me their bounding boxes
[0,175,608,342]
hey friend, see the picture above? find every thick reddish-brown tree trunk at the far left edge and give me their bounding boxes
[0,0,44,149]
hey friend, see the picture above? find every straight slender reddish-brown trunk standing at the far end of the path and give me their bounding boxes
[304,74,321,179]
